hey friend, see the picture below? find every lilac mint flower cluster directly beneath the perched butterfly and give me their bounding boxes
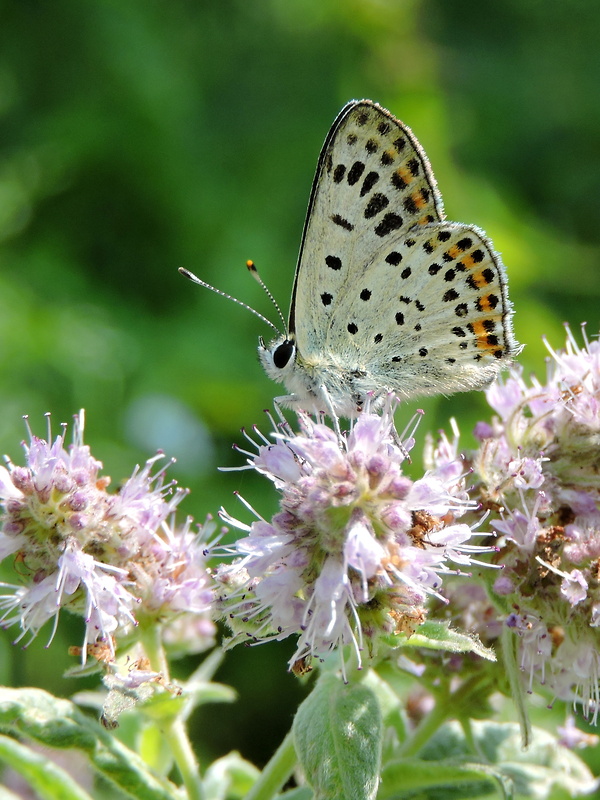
[216,397,489,668]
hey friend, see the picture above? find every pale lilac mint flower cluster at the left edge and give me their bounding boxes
[0,412,213,659]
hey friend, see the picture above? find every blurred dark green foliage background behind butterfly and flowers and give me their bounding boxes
[0,0,600,776]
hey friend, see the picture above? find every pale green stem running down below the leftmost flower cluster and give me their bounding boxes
[141,625,205,800]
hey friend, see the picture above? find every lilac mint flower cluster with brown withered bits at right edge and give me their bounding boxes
[471,329,600,724]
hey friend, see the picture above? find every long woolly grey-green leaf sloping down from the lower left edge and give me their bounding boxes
[0,687,177,800]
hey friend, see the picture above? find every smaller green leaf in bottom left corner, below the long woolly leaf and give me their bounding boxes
[0,736,91,800]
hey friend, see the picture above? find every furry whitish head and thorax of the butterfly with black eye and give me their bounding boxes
[258,334,380,418]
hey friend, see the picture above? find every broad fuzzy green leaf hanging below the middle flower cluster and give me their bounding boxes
[293,673,383,800]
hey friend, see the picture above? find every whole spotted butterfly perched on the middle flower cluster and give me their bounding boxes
[184,100,519,418]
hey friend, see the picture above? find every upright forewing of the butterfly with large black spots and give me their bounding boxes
[290,100,443,358]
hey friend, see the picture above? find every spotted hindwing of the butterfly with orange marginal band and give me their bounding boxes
[323,222,515,397]
